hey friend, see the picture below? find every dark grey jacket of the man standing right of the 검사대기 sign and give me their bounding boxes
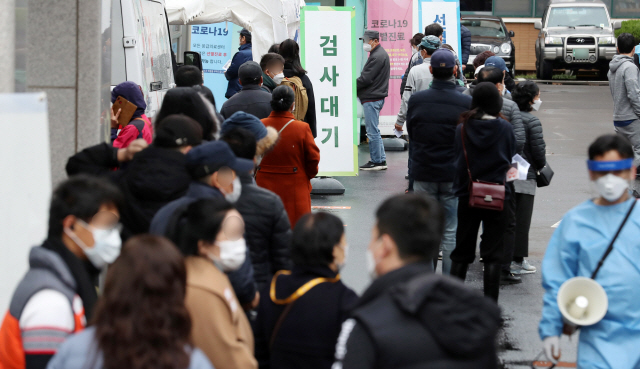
[356,45,391,102]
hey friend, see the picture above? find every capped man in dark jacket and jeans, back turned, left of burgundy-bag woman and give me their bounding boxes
[407,49,471,274]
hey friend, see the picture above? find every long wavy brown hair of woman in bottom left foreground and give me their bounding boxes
[92,235,191,369]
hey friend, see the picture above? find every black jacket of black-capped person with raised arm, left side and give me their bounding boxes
[67,143,191,238]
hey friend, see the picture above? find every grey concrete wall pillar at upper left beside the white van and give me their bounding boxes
[26,0,110,185]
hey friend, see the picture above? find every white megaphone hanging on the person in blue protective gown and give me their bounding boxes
[558,277,609,327]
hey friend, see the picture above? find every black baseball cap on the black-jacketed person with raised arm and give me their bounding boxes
[153,114,202,148]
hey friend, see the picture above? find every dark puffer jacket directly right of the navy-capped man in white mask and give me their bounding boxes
[236,174,292,290]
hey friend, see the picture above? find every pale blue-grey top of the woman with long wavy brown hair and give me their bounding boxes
[47,327,214,369]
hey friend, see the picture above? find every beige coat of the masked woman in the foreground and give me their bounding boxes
[185,256,258,369]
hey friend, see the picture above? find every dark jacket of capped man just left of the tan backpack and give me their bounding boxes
[220,85,273,119]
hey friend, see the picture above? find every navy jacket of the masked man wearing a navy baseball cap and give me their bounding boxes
[149,181,257,304]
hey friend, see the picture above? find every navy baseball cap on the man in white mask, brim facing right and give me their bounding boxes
[187,141,253,179]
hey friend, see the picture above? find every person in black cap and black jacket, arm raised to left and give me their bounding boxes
[66,115,202,238]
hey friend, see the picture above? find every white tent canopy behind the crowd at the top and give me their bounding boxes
[166,0,305,61]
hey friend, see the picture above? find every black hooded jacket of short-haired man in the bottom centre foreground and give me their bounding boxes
[336,263,500,369]
